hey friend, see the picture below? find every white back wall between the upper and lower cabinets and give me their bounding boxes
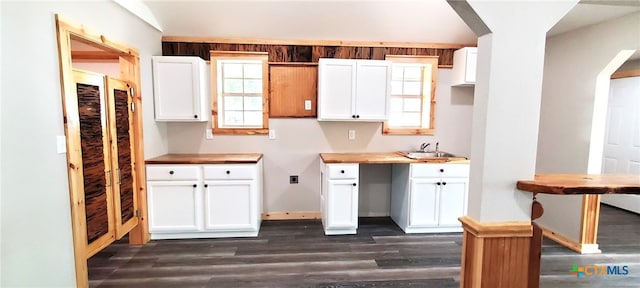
[168,69,473,215]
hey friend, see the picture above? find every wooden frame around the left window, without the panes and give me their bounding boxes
[209,50,269,135]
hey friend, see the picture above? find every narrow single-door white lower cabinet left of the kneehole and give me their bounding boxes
[320,162,359,235]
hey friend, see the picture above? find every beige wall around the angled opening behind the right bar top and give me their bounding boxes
[536,13,640,241]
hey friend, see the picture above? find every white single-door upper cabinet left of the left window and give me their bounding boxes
[152,56,210,122]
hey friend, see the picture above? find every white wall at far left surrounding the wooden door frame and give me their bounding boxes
[0,1,167,287]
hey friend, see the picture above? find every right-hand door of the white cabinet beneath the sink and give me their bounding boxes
[439,178,468,226]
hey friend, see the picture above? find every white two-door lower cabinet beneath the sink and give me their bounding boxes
[391,163,469,233]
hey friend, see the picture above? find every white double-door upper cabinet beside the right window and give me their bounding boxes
[318,58,391,121]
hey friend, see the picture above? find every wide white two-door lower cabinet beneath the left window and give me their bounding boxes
[147,161,262,239]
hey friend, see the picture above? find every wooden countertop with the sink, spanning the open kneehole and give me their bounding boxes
[320,152,469,164]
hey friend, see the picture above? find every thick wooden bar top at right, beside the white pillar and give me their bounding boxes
[516,174,640,195]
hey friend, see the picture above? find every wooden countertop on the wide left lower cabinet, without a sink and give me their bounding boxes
[144,153,262,164]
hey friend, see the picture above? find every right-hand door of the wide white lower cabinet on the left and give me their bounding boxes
[204,181,258,231]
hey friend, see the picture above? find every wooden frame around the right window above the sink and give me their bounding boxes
[382,55,439,135]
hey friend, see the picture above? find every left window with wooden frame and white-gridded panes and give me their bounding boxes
[210,51,269,134]
